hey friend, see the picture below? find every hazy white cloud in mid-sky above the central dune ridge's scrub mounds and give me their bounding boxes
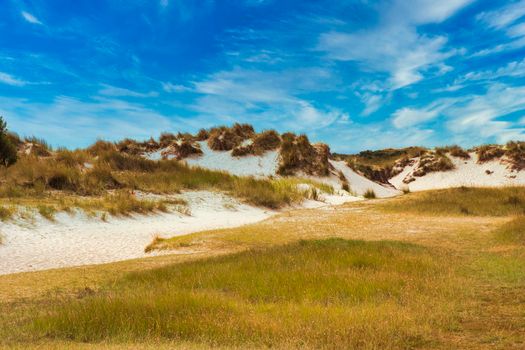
[193,68,344,131]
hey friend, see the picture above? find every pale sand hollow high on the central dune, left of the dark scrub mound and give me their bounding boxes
[186,141,279,177]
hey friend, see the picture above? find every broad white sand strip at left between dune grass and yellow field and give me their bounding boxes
[0,191,275,274]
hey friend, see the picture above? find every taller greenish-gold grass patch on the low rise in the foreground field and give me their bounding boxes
[31,239,457,348]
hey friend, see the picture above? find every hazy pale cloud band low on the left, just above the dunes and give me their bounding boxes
[0,96,180,147]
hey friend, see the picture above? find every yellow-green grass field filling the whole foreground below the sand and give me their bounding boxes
[0,189,525,349]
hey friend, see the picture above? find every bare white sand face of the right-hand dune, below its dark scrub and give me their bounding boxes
[390,153,525,191]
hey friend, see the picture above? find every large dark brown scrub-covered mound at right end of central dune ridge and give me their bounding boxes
[277,133,330,176]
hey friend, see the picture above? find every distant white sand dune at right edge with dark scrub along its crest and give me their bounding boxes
[337,142,525,191]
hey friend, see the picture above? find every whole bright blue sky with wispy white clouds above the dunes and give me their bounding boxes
[0,0,525,152]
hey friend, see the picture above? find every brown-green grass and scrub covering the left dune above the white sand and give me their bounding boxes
[0,118,332,220]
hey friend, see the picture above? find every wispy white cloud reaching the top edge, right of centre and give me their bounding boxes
[318,0,471,89]
